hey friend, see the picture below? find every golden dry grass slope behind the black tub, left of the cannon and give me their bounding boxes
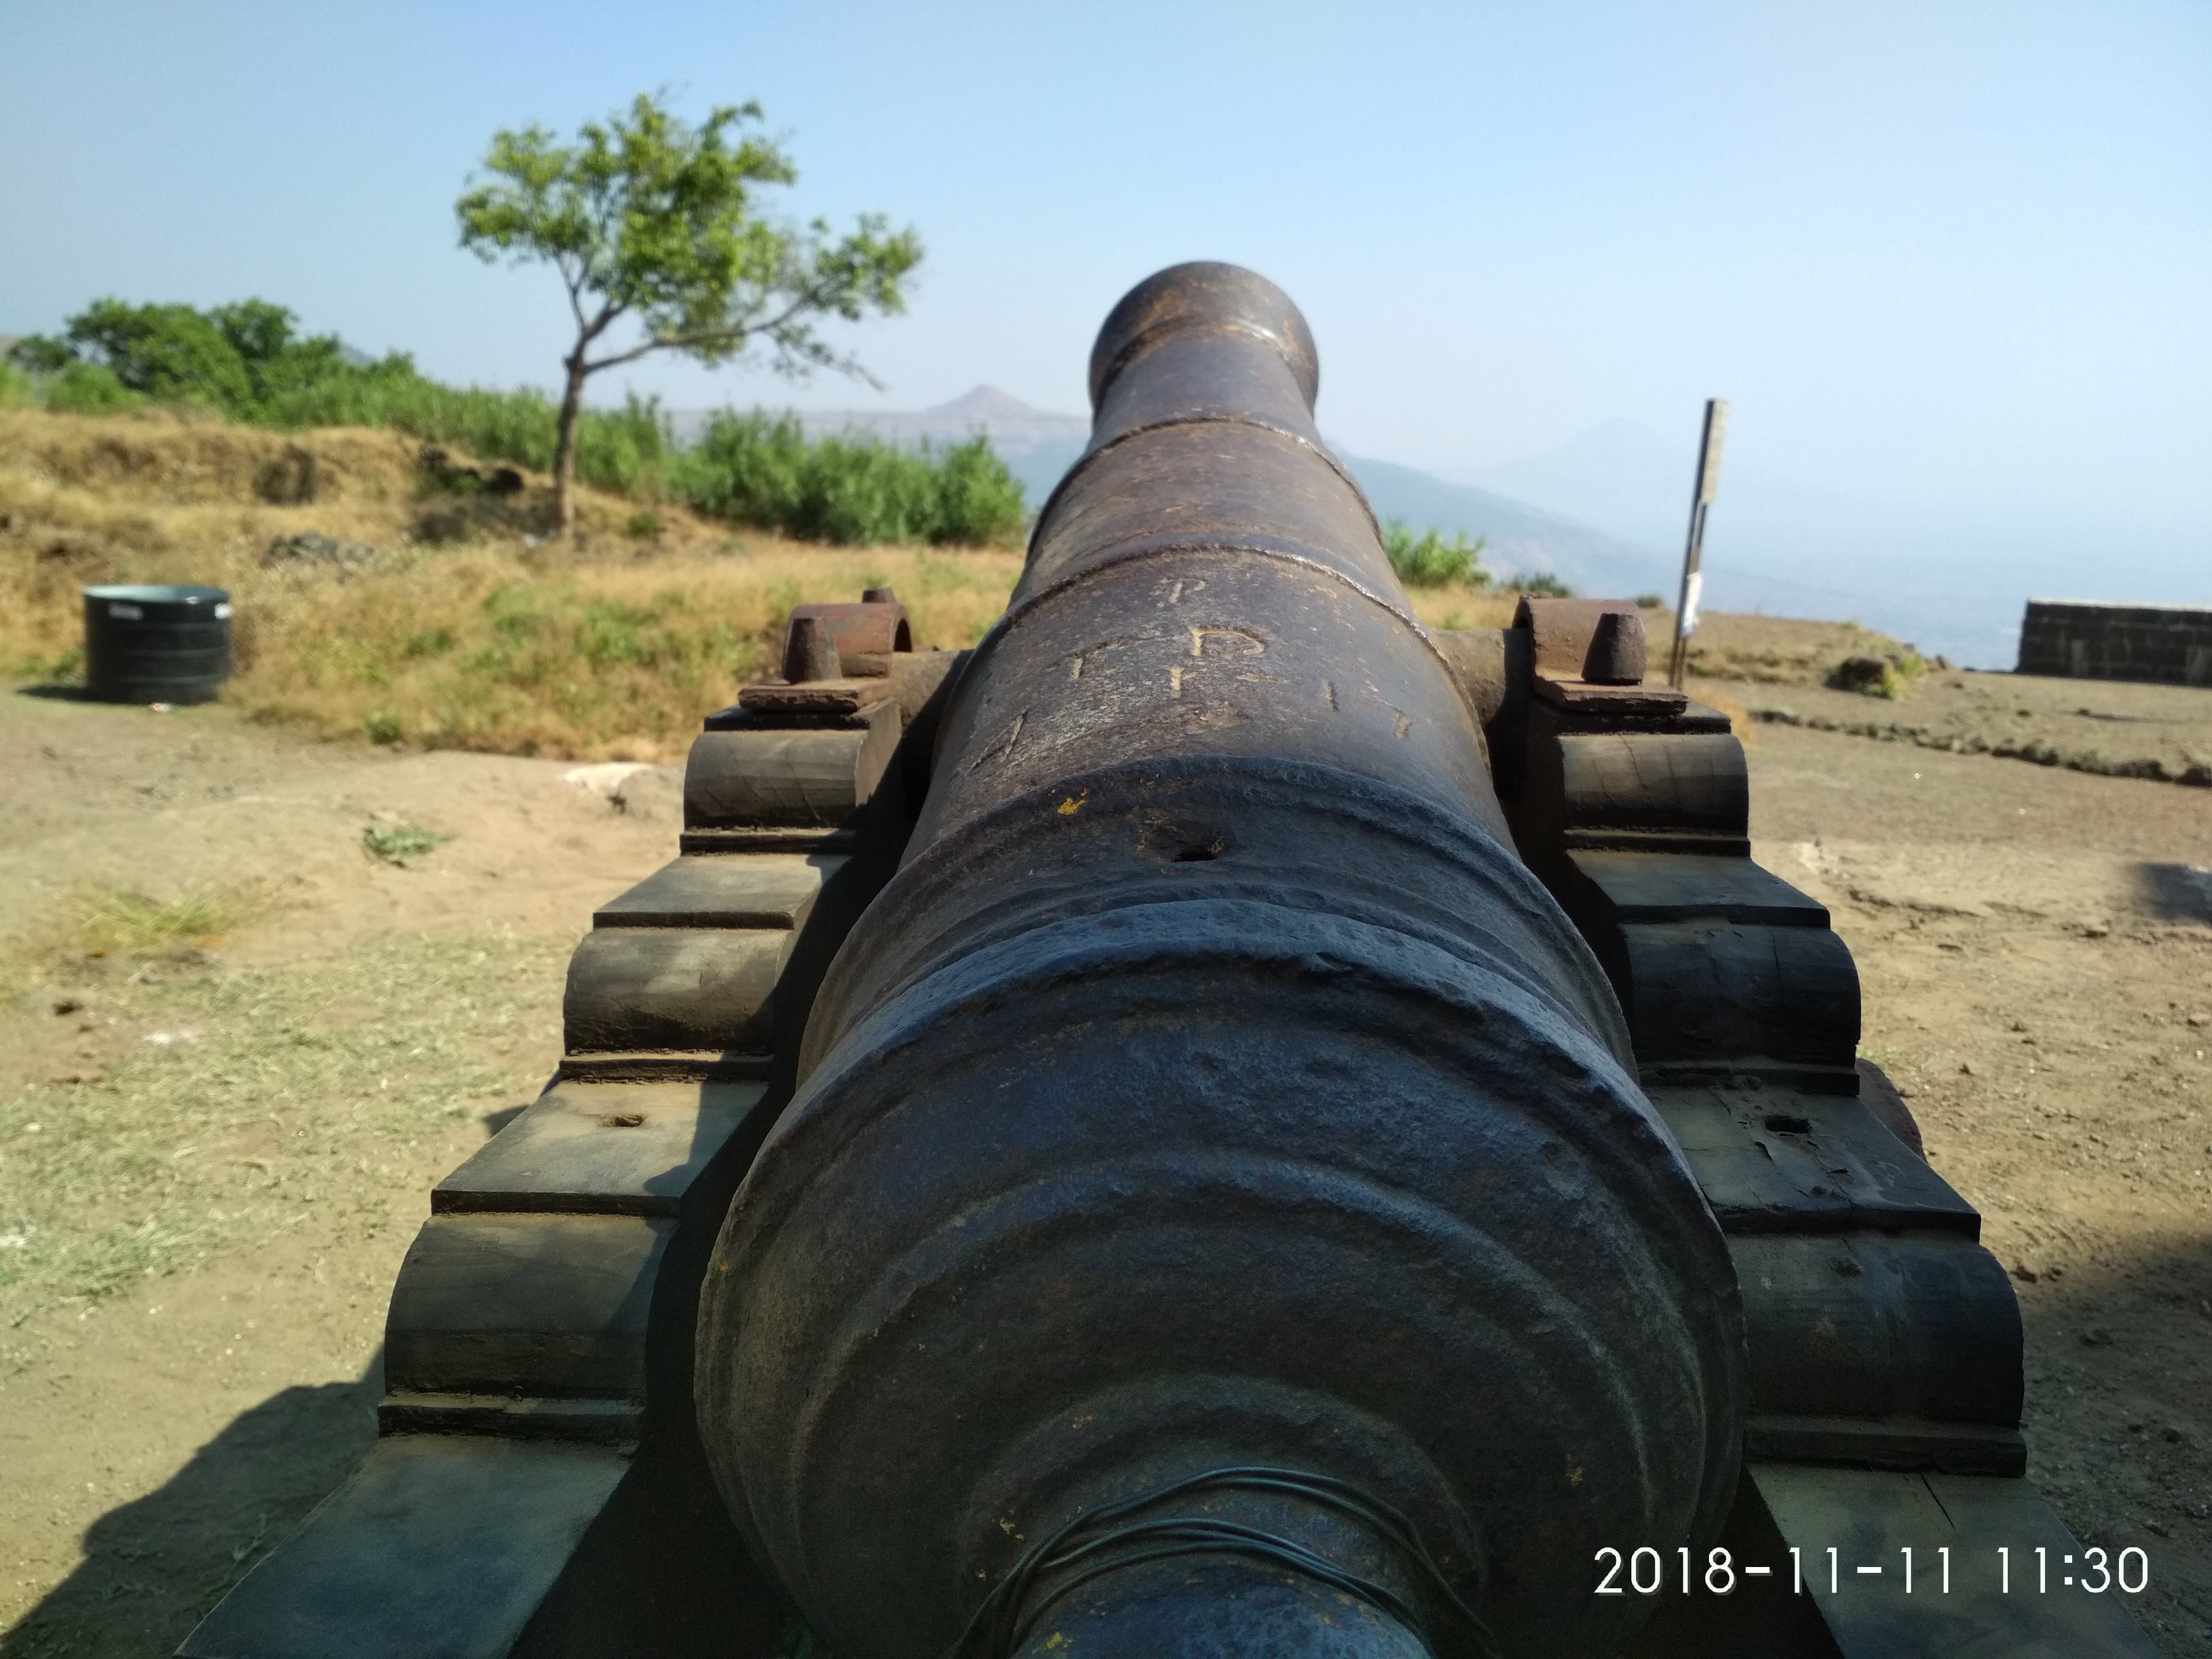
[0,412,1020,761]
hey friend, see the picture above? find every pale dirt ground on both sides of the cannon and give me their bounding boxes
[0,694,2212,1659]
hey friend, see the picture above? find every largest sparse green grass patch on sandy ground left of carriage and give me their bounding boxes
[0,934,568,1331]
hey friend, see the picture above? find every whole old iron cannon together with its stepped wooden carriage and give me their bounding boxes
[181,263,2150,1659]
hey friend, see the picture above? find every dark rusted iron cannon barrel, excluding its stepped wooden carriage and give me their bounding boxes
[697,263,1745,1659]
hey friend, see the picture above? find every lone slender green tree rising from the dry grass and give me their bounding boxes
[454,93,923,533]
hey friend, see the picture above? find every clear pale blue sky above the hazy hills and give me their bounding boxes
[0,0,2212,597]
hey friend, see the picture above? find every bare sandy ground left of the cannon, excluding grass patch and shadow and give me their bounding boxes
[0,694,677,1659]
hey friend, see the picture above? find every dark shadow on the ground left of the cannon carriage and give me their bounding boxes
[0,1352,385,1659]
